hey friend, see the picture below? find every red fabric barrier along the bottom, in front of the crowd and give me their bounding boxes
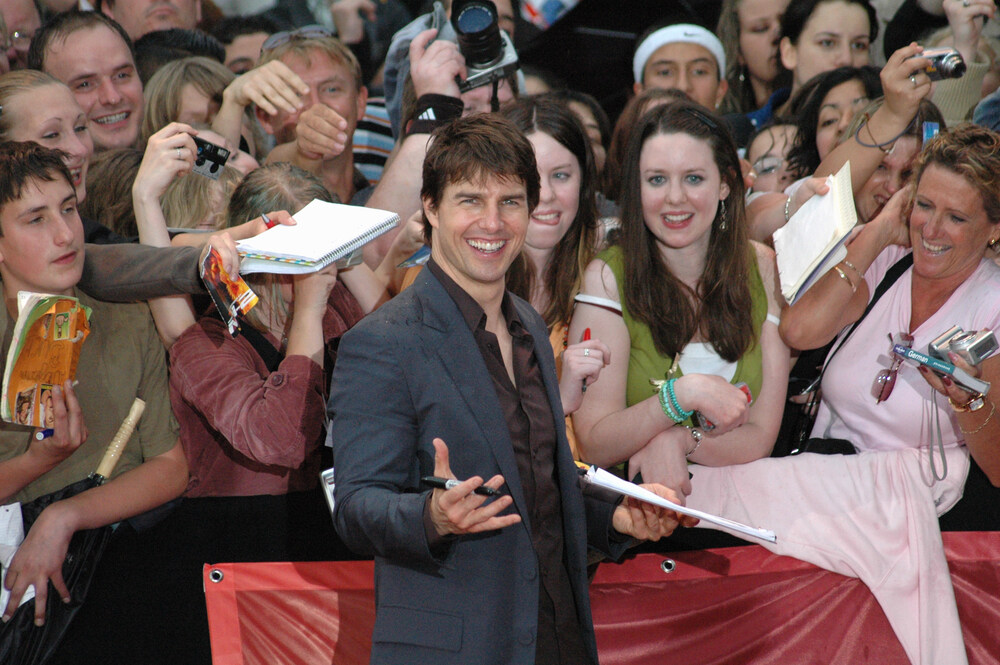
[205,532,1000,665]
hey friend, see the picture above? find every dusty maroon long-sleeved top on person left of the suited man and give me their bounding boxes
[170,282,362,497]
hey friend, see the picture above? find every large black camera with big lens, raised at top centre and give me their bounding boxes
[451,0,520,92]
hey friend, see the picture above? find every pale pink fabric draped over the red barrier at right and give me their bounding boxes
[687,447,969,665]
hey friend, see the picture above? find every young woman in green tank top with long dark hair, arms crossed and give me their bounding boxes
[570,102,789,494]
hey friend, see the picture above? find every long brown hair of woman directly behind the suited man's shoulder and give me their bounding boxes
[500,95,597,329]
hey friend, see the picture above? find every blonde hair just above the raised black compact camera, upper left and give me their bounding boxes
[139,56,236,145]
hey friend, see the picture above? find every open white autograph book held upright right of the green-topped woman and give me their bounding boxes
[773,162,858,303]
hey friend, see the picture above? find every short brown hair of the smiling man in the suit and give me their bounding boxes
[420,113,541,239]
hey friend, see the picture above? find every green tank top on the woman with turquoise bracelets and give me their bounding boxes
[597,246,767,425]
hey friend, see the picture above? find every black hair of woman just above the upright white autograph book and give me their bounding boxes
[788,65,882,178]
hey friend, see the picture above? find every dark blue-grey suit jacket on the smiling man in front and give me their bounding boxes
[330,270,623,665]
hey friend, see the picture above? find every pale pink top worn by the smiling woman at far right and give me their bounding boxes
[812,247,1000,450]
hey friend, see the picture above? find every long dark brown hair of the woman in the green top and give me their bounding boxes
[621,102,756,362]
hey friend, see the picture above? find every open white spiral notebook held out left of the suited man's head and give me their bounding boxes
[236,200,399,275]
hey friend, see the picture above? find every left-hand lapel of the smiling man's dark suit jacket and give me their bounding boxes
[410,269,530,531]
